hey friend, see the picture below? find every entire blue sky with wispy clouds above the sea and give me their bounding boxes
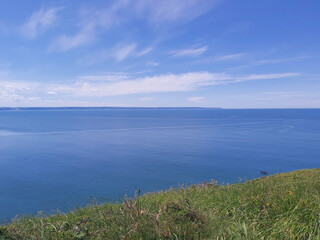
[0,0,320,108]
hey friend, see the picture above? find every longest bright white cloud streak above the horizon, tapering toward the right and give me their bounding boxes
[47,72,299,96]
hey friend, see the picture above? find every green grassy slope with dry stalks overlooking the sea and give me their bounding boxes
[0,169,320,239]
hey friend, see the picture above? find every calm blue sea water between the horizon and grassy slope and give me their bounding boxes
[0,109,320,219]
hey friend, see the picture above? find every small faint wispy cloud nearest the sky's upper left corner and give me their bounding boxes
[20,7,62,39]
